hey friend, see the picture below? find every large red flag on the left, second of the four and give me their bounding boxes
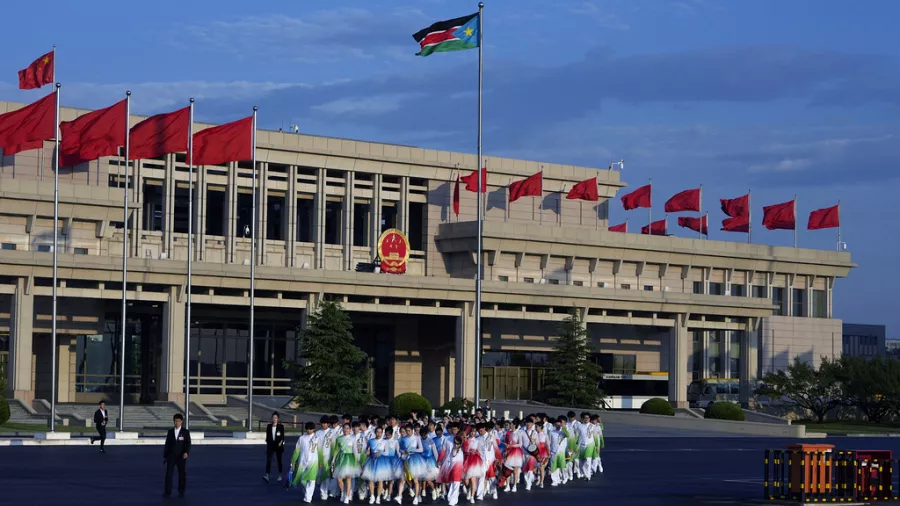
[59,100,127,167]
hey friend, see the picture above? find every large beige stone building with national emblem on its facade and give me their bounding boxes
[0,102,853,412]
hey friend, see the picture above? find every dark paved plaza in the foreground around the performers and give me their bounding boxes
[0,436,900,506]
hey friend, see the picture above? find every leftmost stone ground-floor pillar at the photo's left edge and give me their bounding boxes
[6,278,34,406]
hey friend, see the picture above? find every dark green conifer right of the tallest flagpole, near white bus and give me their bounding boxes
[544,314,603,409]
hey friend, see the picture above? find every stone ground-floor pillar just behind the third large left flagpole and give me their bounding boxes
[159,287,186,405]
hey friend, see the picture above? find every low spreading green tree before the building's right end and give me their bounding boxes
[756,357,843,423]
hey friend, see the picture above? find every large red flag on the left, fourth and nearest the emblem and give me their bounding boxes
[194,116,253,165]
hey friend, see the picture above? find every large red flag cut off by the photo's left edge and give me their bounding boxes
[0,92,56,155]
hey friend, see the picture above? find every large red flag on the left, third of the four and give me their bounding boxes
[128,107,191,160]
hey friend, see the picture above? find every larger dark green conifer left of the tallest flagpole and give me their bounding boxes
[286,301,371,413]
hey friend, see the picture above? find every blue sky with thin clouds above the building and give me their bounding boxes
[0,0,900,338]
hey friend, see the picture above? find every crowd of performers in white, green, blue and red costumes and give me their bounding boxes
[285,411,604,506]
